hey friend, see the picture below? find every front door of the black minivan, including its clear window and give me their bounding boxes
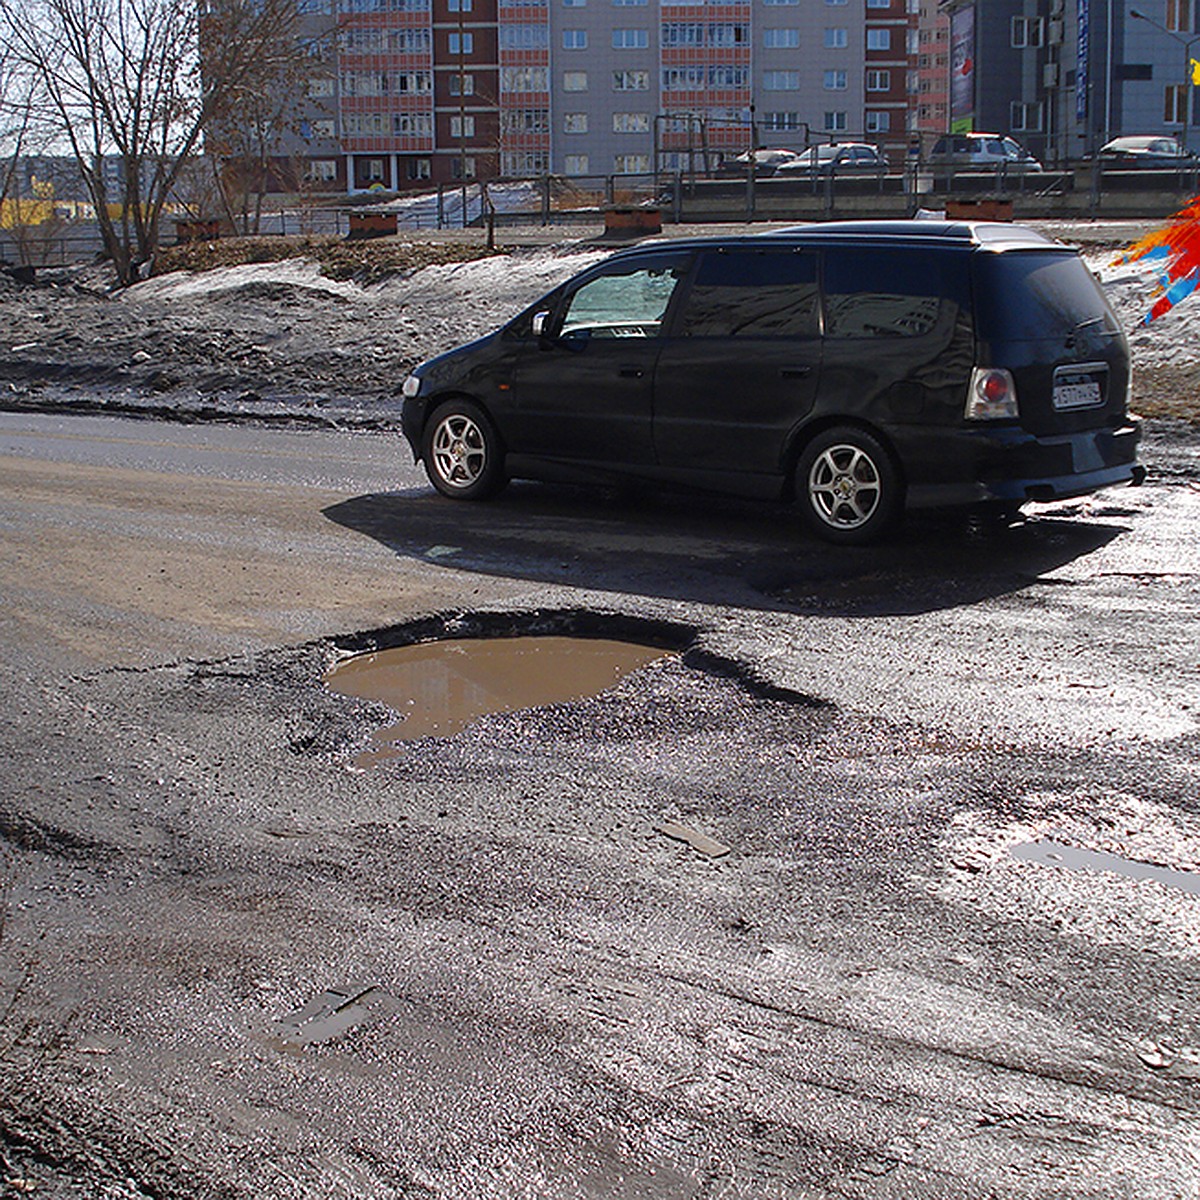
[506,252,690,466]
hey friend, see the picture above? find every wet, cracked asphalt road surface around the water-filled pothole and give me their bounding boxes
[0,415,1200,1200]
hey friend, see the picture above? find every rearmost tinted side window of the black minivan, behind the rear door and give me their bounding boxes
[824,250,971,337]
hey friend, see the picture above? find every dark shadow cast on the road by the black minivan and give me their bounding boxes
[323,484,1128,617]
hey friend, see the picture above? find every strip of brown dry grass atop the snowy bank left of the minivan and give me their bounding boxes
[154,236,505,283]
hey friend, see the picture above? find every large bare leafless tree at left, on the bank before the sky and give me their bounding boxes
[0,0,319,283]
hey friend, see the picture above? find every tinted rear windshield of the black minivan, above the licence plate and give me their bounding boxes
[974,251,1121,341]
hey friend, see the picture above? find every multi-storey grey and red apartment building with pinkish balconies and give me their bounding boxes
[288,0,919,191]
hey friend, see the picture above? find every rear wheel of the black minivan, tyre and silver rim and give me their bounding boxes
[796,425,904,546]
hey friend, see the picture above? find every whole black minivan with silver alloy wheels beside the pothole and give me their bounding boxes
[403,221,1144,544]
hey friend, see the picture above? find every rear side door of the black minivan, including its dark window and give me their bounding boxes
[654,244,821,486]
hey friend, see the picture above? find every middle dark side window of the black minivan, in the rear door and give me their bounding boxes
[679,250,820,337]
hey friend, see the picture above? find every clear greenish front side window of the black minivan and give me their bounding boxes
[559,258,686,337]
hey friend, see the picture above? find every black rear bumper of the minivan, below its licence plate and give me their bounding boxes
[899,420,1146,508]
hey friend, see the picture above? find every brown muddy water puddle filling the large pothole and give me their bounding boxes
[325,637,667,767]
